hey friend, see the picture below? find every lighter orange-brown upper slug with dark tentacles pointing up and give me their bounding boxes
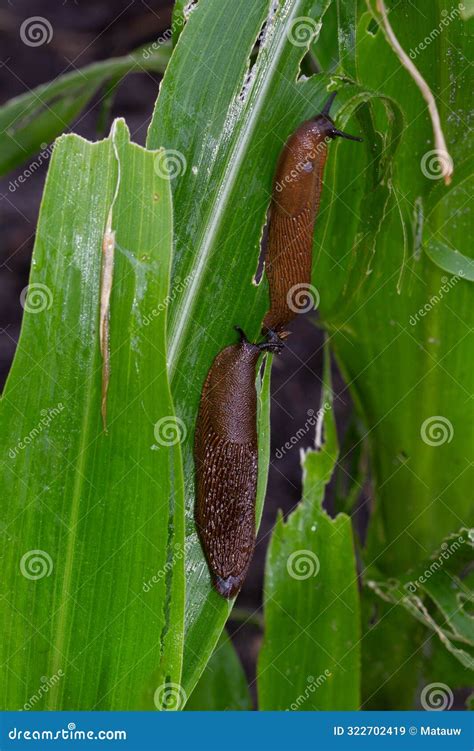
[262,92,362,333]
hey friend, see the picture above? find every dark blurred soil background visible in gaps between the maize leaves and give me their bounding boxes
[0,0,360,700]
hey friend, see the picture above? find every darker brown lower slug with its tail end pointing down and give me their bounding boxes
[194,329,281,598]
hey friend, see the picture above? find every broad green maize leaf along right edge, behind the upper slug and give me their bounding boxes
[304,2,474,709]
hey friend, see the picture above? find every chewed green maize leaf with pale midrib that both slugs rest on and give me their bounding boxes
[148,0,399,693]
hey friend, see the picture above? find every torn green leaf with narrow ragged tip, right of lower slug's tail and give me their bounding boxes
[258,352,360,711]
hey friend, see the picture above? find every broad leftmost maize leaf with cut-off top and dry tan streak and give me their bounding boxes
[0,121,184,710]
